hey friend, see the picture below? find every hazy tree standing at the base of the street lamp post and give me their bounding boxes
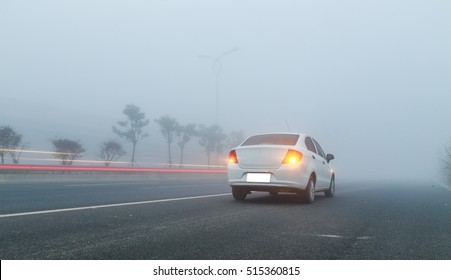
[199,125,227,167]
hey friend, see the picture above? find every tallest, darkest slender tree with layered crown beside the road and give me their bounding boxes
[113,104,149,166]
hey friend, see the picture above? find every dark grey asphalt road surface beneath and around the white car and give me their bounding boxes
[0,175,451,260]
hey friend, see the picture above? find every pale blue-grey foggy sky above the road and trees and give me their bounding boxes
[0,0,451,179]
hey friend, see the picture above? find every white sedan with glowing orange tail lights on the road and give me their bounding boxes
[228,133,335,203]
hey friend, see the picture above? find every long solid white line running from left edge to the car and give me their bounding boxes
[0,193,230,218]
